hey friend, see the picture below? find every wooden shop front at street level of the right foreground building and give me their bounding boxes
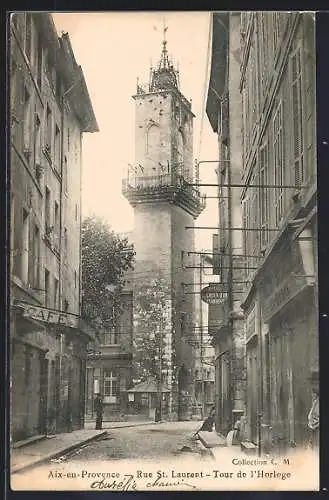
[261,223,318,451]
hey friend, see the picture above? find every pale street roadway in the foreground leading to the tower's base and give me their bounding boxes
[53,422,211,463]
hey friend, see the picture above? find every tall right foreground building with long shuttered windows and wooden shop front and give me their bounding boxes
[240,12,318,451]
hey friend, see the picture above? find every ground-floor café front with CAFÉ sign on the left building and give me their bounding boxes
[10,300,90,441]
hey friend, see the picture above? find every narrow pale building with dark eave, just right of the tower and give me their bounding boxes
[206,12,246,434]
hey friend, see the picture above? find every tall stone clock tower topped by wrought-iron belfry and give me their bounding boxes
[123,33,204,420]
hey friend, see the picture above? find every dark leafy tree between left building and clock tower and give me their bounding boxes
[81,216,135,329]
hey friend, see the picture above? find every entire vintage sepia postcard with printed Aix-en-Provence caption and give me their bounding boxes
[8,11,320,492]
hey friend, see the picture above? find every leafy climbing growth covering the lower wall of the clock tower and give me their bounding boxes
[133,277,174,383]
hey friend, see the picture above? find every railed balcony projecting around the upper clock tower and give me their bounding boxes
[122,173,206,219]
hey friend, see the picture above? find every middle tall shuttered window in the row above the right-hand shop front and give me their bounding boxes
[273,101,284,226]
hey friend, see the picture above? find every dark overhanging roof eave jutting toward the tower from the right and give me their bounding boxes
[206,12,229,132]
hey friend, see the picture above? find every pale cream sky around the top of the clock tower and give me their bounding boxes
[53,11,217,252]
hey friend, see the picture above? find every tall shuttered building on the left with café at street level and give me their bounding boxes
[10,12,98,440]
